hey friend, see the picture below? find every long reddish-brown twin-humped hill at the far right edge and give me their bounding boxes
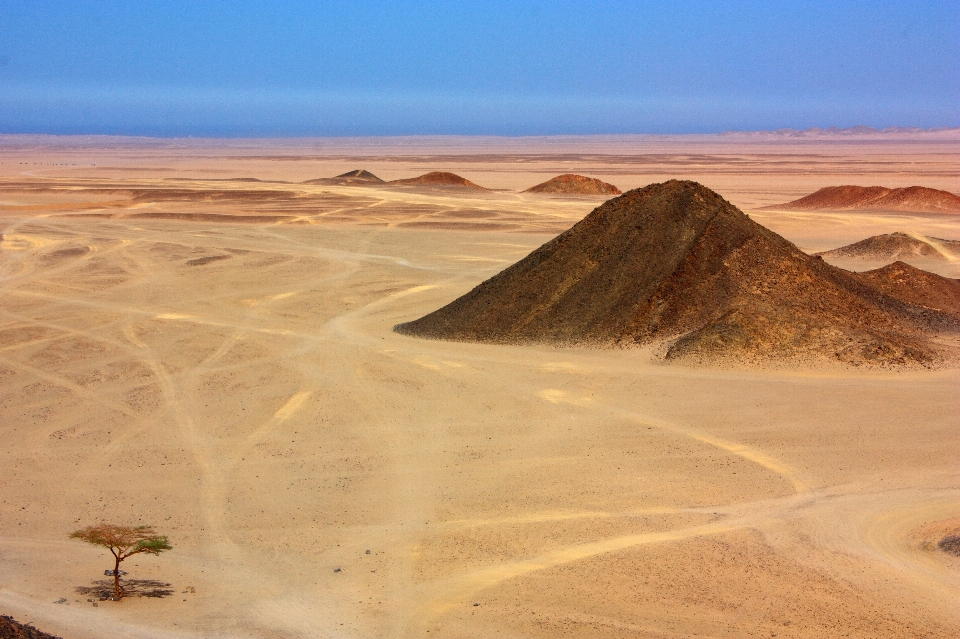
[765,186,960,213]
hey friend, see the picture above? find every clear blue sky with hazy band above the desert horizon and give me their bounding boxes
[0,0,960,137]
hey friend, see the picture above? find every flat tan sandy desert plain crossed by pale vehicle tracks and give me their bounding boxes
[0,132,960,639]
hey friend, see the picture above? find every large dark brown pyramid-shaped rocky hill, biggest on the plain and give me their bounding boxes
[395,180,960,366]
